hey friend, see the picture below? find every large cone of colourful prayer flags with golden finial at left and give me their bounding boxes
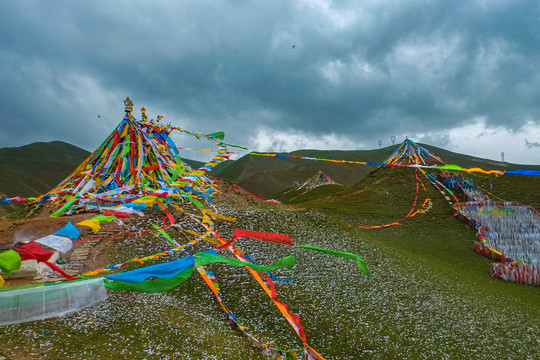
[38,98,228,216]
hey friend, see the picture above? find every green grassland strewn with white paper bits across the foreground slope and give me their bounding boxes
[0,169,540,359]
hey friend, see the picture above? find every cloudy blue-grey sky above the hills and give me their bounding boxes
[0,0,540,164]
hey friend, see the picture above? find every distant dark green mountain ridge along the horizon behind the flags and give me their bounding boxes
[0,141,540,205]
